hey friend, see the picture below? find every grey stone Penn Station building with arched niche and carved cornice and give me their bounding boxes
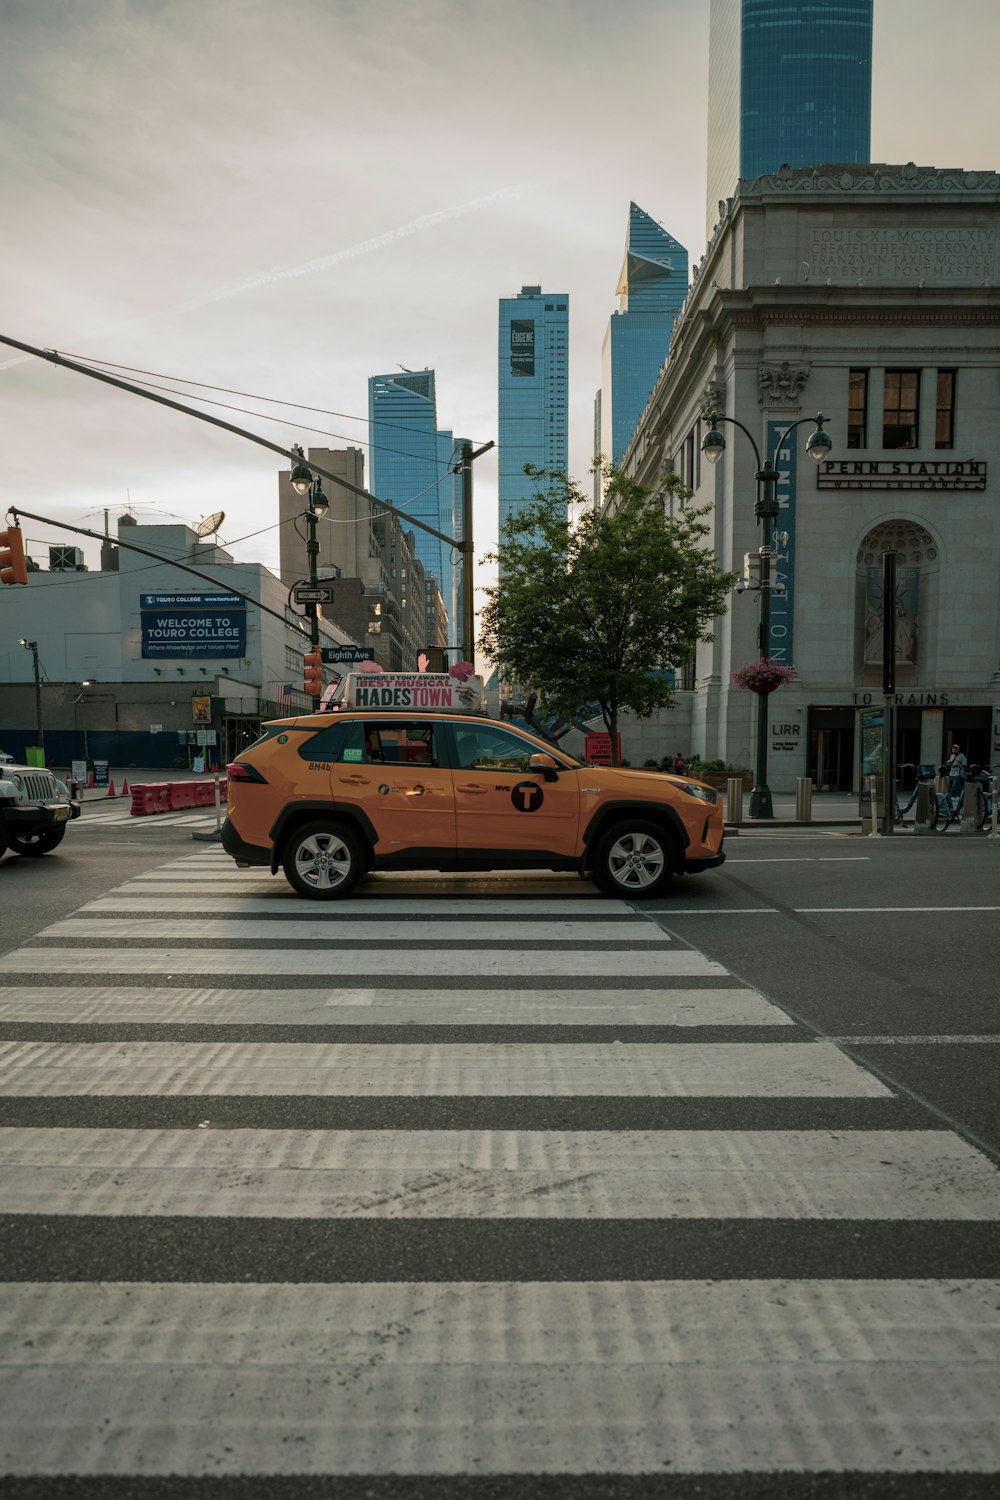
[622,164,1000,791]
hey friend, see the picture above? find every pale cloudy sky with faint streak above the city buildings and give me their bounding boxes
[0,0,1000,627]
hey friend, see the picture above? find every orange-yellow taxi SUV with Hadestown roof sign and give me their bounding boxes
[222,672,726,900]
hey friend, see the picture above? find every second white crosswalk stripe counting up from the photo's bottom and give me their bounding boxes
[0,1128,1000,1223]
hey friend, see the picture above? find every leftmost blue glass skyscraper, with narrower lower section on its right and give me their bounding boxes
[369,369,462,642]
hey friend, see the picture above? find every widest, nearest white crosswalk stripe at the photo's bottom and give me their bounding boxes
[3,1278,1000,1476]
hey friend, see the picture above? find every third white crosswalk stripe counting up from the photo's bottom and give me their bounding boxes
[0,1044,892,1100]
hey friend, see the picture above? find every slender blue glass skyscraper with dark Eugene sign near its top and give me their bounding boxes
[498,287,570,527]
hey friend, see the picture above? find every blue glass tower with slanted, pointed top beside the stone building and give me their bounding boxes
[600,203,688,464]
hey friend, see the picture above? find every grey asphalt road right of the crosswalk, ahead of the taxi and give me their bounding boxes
[636,831,1000,1160]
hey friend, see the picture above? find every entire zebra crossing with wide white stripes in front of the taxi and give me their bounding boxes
[0,848,1000,1500]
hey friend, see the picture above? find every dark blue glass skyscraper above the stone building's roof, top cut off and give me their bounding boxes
[706,0,874,237]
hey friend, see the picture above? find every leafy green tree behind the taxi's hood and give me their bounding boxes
[480,470,736,764]
